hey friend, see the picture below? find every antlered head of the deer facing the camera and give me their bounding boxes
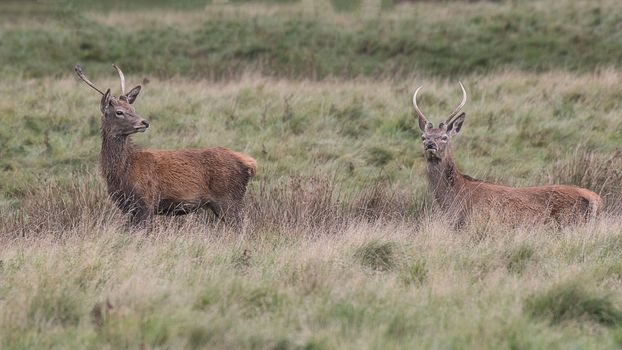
[413,82,467,161]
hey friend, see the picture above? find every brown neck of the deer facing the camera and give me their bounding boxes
[426,151,465,209]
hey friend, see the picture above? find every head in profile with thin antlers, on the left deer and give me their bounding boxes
[74,64,149,136]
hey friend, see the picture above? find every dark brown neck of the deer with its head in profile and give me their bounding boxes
[100,129,134,193]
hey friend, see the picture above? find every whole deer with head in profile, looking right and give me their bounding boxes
[75,65,256,226]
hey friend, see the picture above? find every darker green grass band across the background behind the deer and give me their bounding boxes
[0,0,622,78]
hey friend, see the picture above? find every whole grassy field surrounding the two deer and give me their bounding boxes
[0,0,622,349]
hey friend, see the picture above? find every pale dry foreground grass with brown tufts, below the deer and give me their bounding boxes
[0,183,622,349]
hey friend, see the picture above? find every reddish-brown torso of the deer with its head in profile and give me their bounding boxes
[111,147,256,217]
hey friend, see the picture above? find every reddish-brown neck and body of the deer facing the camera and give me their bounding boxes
[427,153,603,226]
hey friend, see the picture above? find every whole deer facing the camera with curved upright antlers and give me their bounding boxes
[413,83,603,227]
